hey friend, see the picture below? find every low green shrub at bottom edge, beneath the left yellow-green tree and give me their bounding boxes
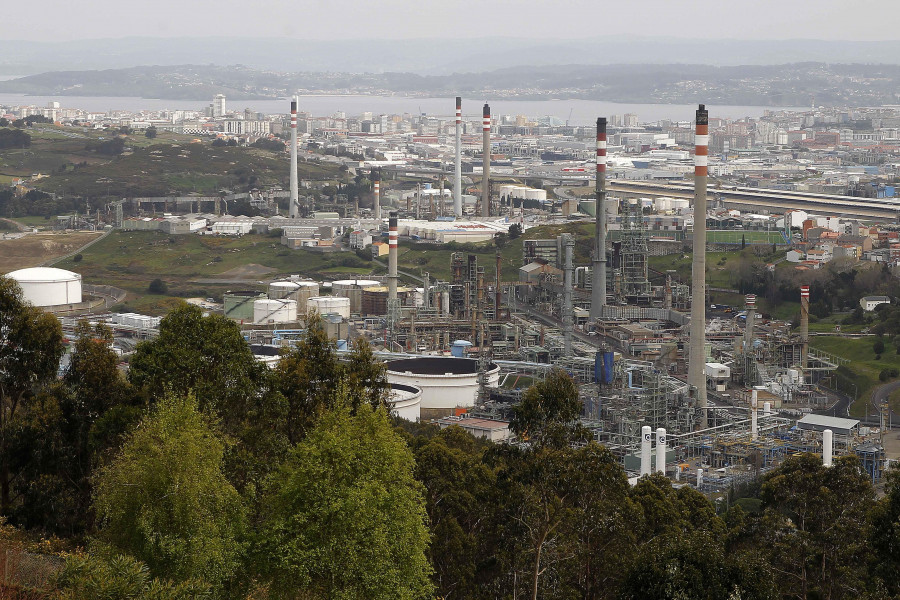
[52,554,209,600]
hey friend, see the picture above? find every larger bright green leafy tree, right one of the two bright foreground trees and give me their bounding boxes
[256,402,432,600]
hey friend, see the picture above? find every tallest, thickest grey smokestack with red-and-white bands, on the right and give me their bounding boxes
[688,104,709,429]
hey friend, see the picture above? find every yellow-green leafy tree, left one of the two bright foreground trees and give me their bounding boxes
[94,396,245,592]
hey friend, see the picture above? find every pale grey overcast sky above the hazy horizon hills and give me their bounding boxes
[7,0,900,41]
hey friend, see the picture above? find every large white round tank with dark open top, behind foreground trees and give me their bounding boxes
[387,356,500,419]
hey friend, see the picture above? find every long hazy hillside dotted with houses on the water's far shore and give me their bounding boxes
[0,63,900,106]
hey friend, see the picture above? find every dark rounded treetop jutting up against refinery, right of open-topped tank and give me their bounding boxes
[509,369,584,446]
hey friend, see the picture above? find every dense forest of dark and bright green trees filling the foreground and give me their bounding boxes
[0,277,900,600]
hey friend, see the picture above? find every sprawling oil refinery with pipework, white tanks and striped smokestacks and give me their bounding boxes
[5,98,886,492]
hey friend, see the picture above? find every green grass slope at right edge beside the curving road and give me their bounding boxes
[809,336,900,417]
